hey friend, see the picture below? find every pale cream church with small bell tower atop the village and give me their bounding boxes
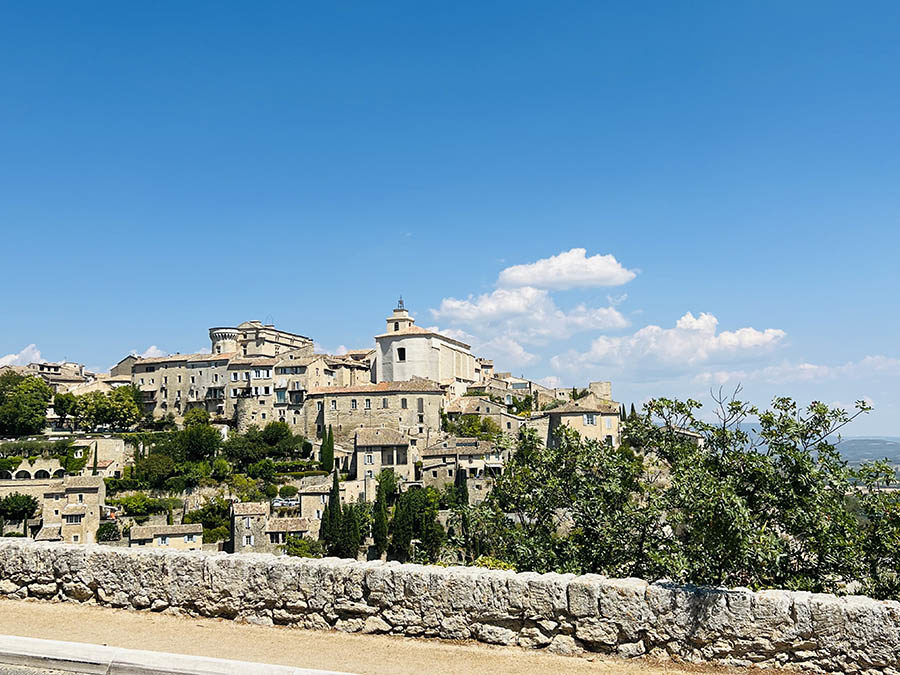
[373,298,479,395]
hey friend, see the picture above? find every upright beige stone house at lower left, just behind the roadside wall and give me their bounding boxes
[35,476,106,544]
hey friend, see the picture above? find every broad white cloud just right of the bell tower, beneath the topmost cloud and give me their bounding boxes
[431,286,628,343]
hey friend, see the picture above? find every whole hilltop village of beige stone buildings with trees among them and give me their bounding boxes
[0,299,624,557]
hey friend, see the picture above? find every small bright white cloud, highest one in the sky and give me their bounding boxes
[497,248,636,290]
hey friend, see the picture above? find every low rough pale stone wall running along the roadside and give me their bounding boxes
[0,540,900,674]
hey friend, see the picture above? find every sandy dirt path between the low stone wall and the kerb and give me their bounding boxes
[0,599,745,675]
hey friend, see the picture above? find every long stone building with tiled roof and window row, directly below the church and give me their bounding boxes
[303,380,443,446]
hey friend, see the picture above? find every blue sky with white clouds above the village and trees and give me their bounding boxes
[0,0,900,436]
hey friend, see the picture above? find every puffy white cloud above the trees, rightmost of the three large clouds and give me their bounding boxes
[551,312,785,373]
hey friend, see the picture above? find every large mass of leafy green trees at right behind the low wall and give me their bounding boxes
[460,398,900,598]
